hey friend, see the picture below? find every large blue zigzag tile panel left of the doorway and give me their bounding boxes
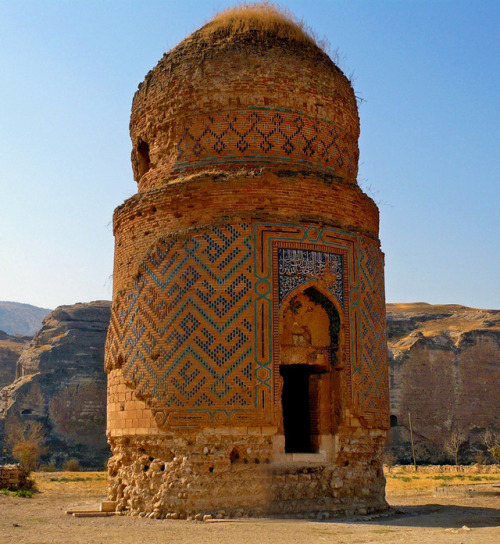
[107,223,254,413]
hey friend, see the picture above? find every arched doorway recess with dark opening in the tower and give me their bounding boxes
[279,287,341,453]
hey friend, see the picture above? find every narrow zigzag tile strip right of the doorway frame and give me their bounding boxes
[359,236,389,413]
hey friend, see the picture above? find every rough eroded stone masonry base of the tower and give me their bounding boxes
[108,430,388,519]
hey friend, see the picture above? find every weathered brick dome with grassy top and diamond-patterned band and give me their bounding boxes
[130,4,359,191]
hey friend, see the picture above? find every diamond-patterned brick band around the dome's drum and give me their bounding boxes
[174,107,359,177]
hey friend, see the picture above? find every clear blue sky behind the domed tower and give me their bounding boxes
[0,0,500,308]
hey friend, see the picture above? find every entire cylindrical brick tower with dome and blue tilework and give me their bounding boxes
[106,6,389,517]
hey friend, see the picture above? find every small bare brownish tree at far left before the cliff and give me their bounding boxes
[6,420,47,472]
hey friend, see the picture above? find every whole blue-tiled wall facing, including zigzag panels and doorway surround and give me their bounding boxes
[106,219,389,428]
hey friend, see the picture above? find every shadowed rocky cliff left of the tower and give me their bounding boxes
[0,301,111,469]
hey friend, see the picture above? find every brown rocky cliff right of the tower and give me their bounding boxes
[387,303,500,462]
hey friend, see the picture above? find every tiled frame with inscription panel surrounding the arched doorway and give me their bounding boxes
[254,223,389,426]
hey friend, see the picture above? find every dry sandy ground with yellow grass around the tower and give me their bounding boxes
[0,471,500,544]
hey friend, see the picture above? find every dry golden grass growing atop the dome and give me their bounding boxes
[200,2,328,50]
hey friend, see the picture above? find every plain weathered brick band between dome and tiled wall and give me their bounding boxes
[113,169,378,293]
